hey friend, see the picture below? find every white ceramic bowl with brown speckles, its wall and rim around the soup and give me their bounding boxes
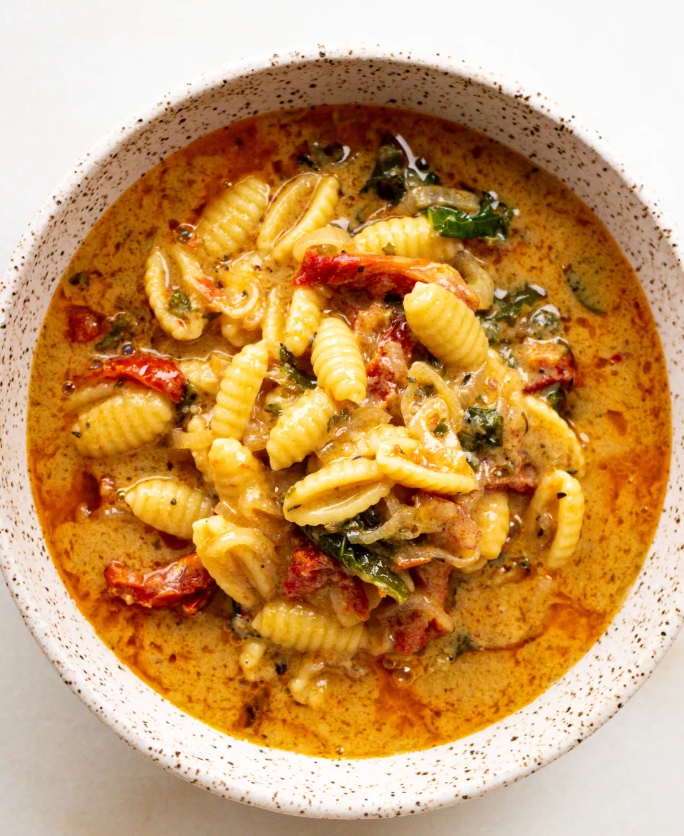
[0,47,684,818]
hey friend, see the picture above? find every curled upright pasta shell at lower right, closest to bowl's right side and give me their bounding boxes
[525,470,584,569]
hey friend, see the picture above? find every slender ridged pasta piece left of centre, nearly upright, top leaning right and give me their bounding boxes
[211,341,268,441]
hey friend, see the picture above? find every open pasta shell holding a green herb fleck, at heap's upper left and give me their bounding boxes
[144,245,207,340]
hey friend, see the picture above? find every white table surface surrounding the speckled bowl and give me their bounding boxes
[0,0,684,836]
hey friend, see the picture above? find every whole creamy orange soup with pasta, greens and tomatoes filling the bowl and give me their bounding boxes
[28,105,670,757]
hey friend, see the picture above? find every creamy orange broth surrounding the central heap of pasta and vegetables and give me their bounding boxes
[28,106,670,757]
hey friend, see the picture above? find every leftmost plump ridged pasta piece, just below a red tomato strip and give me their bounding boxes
[71,384,175,458]
